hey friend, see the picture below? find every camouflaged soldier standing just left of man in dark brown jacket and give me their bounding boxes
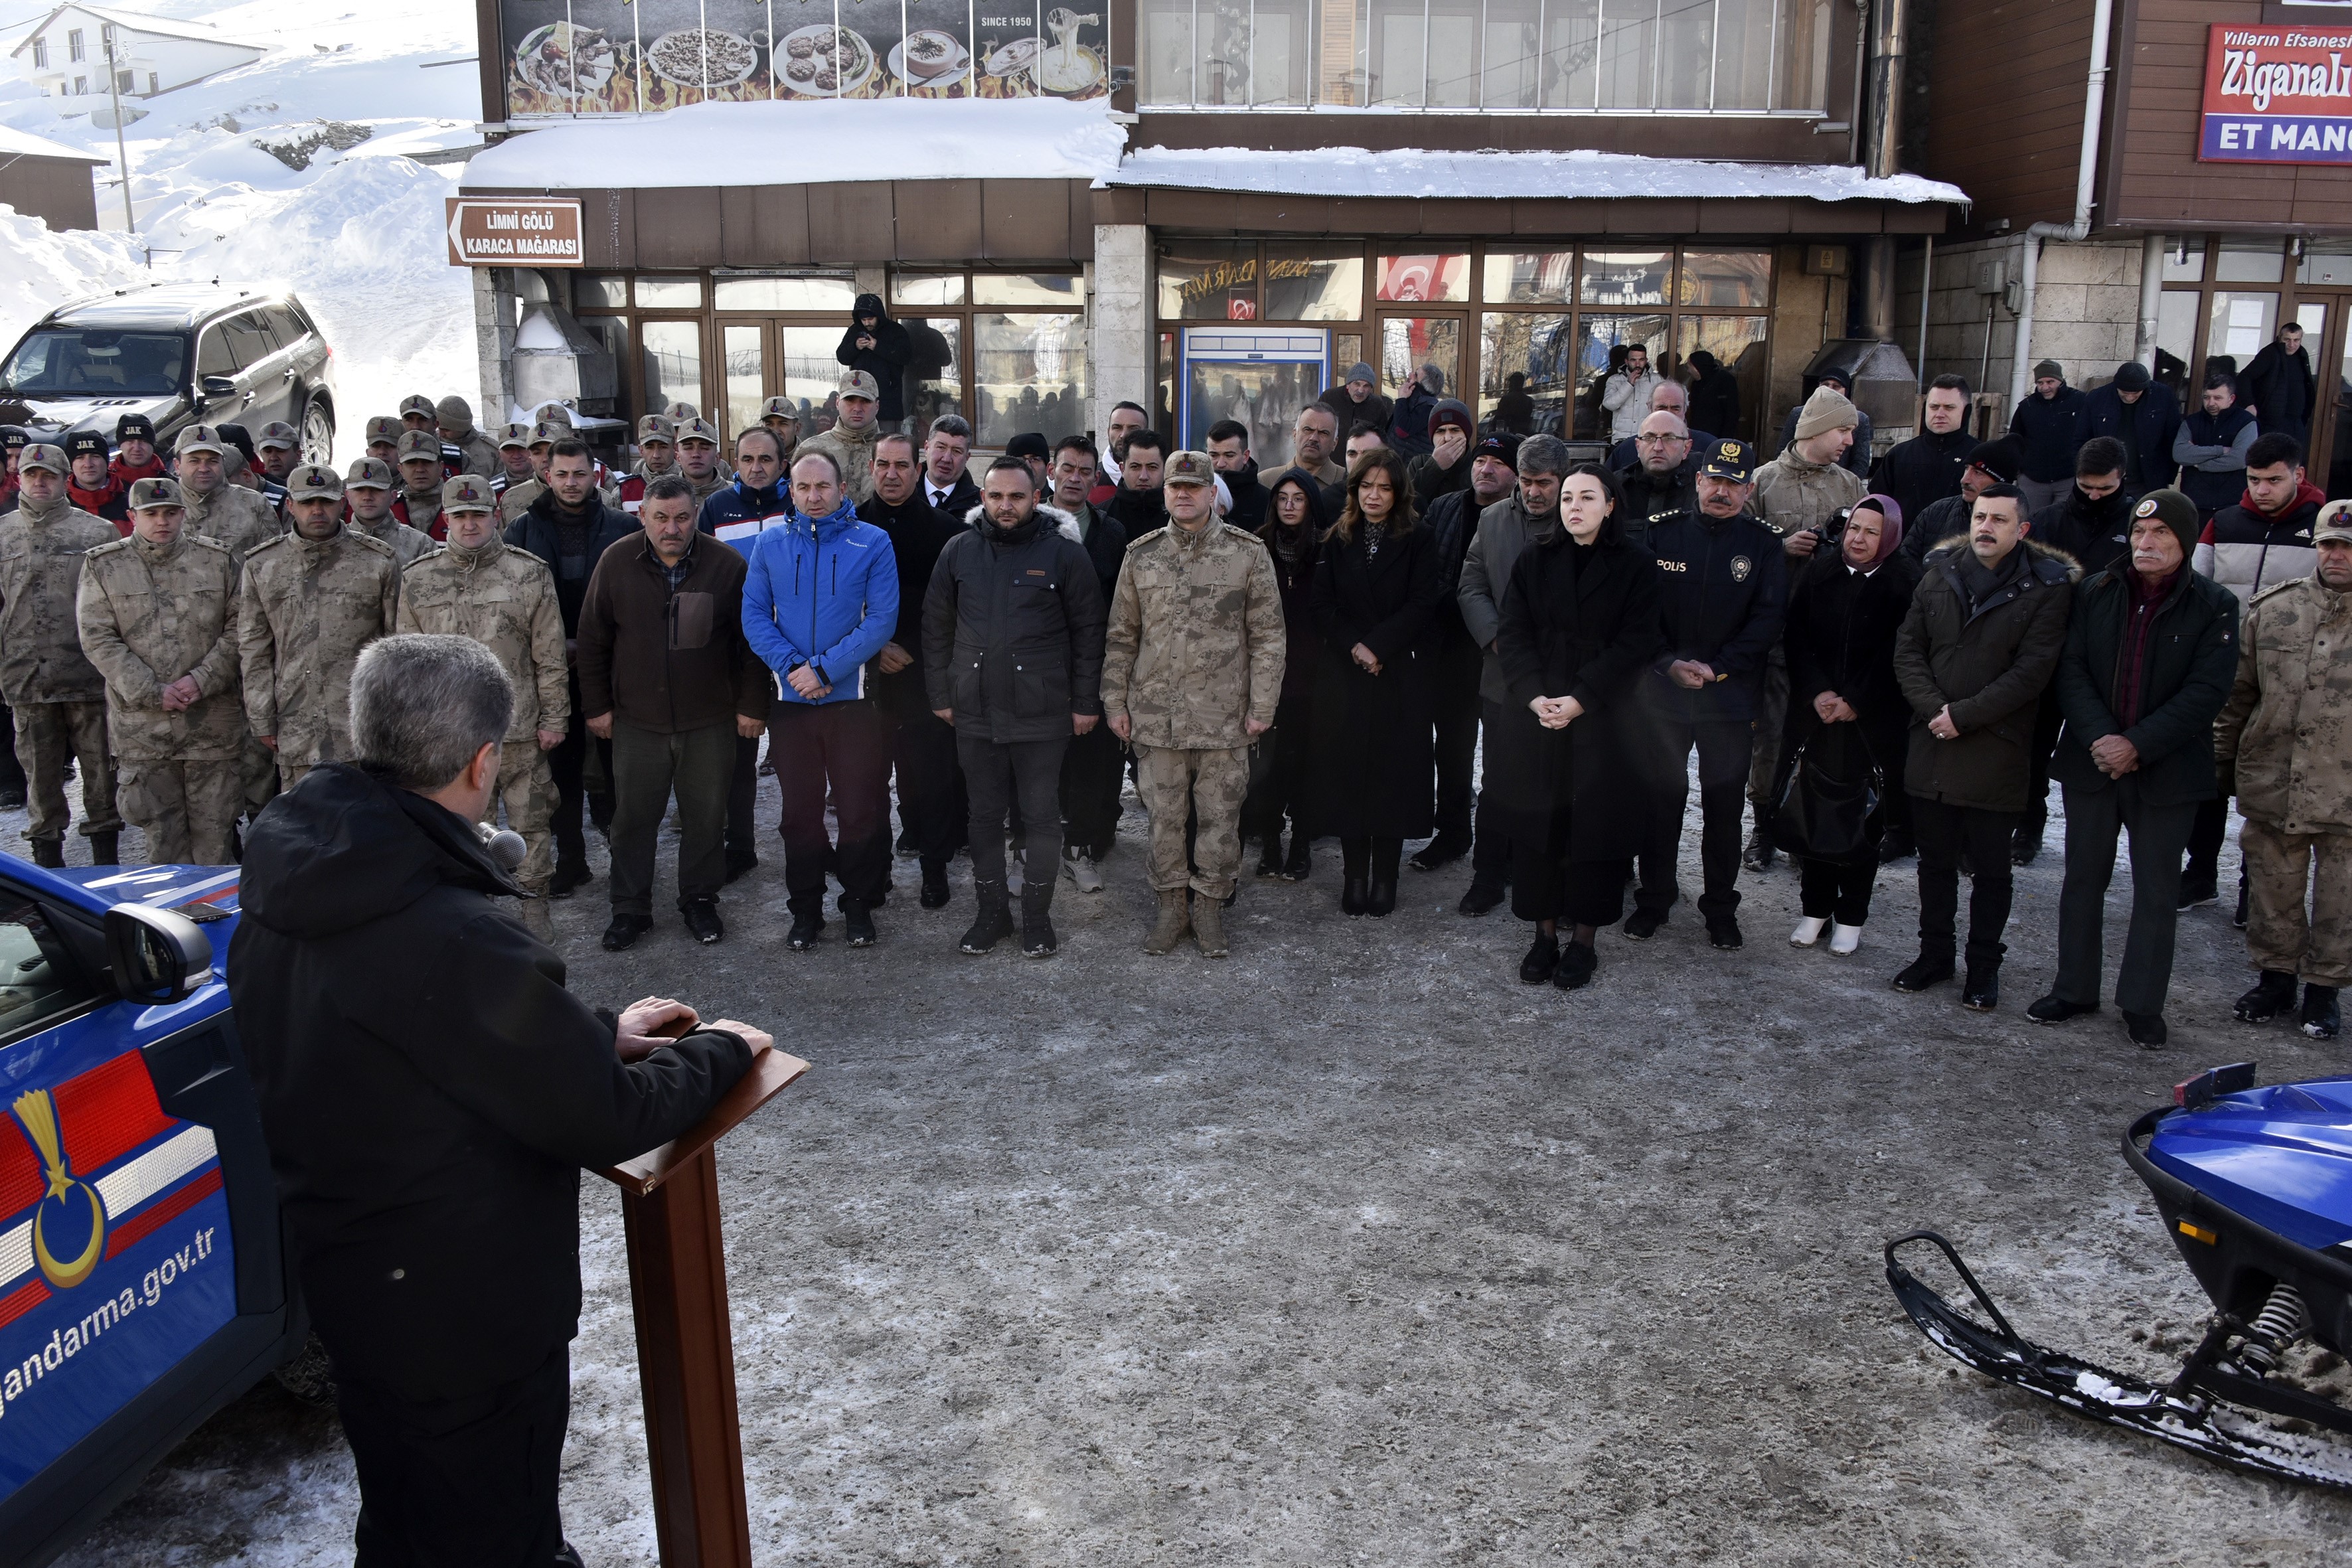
[400,475,572,945]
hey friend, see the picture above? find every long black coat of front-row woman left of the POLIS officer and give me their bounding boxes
[1489,529,1660,860]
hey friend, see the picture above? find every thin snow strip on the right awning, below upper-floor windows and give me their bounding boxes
[1101,148,1968,207]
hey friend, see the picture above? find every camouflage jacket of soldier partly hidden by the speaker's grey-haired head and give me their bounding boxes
[400,540,572,743]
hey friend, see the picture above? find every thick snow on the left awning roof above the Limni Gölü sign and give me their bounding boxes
[463,99,1127,191]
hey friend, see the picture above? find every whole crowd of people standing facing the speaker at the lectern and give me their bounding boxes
[0,338,2352,1046]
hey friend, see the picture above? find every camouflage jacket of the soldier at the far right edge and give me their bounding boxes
[2213,576,2352,832]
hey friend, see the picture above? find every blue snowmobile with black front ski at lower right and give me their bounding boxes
[1886,1063,2352,1490]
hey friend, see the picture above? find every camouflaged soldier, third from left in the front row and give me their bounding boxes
[238,463,400,790]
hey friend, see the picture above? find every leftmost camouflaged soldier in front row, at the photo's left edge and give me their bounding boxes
[0,444,122,868]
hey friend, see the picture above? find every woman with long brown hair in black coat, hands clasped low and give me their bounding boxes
[1310,447,1447,915]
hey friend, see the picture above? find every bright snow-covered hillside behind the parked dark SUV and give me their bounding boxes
[0,0,482,461]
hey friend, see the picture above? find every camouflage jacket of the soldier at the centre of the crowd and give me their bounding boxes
[1103,522,1284,750]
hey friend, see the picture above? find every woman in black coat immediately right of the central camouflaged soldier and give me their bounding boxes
[1242,468,1331,882]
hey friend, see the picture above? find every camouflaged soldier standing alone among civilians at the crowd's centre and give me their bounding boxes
[1103,451,1284,959]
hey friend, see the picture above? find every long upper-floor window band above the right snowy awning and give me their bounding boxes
[1140,0,1832,116]
